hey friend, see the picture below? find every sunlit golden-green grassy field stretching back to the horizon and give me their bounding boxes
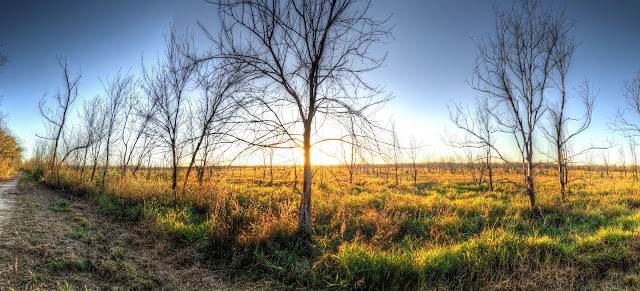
[25,167,640,289]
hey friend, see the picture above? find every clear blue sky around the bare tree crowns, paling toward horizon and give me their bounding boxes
[0,0,640,164]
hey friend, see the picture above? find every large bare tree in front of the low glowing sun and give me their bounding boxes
[205,0,390,236]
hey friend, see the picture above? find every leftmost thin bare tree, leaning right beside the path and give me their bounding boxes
[37,58,82,171]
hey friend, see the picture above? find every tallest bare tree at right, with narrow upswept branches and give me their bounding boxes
[471,1,573,211]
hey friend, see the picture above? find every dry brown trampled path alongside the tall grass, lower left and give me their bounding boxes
[0,177,264,290]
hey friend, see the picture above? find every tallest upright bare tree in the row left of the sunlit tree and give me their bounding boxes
[142,27,197,195]
